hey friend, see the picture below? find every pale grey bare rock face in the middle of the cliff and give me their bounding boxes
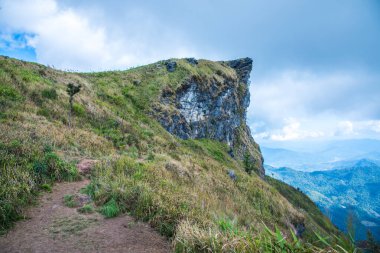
[160,76,245,147]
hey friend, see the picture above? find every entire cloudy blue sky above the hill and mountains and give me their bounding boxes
[0,0,380,146]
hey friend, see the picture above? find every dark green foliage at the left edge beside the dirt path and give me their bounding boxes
[0,140,79,231]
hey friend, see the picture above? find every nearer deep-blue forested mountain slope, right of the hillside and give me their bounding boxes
[266,159,380,240]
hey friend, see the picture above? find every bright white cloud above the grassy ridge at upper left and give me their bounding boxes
[0,0,197,71]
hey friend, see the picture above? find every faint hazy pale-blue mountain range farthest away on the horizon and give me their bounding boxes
[261,139,380,171]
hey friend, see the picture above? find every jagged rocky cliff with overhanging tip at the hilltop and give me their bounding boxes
[155,58,264,176]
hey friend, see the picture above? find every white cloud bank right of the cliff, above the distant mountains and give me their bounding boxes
[248,70,380,141]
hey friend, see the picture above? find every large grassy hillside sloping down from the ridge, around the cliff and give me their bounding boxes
[0,57,350,252]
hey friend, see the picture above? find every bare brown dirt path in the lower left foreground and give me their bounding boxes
[0,180,170,253]
